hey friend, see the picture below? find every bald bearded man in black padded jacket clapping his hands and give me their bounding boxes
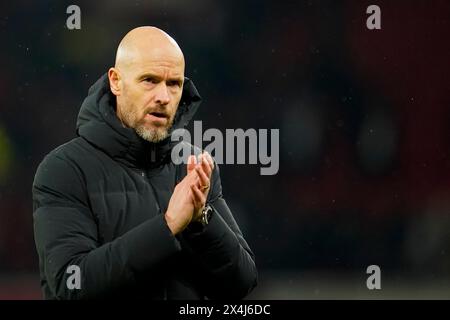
[32,27,257,300]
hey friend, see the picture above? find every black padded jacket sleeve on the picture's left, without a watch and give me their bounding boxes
[32,154,181,299]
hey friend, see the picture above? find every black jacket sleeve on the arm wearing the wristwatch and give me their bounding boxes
[183,164,258,299]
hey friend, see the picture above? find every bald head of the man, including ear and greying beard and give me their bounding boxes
[108,27,184,142]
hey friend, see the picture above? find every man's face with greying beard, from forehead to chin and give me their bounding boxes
[117,49,184,142]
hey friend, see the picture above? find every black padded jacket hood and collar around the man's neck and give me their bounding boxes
[76,74,201,168]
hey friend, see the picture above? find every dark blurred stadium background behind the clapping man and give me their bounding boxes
[0,0,450,299]
